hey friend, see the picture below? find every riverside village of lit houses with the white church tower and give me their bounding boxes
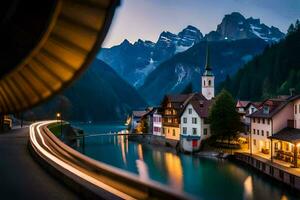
[128,45,300,168]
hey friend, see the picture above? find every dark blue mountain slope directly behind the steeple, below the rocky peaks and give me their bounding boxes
[139,38,267,105]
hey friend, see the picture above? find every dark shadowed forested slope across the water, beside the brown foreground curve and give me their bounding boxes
[26,59,146,122]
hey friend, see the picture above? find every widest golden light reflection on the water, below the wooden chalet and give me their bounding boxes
[165,152,183,190]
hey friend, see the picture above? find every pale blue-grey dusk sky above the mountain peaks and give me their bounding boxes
[103,0,300,47]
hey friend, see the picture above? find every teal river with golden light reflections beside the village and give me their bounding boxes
[71,123,300,200]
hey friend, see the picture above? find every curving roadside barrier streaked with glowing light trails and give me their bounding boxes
[29,121,191,199]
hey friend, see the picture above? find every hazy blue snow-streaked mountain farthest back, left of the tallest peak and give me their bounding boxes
[98,26,203,87]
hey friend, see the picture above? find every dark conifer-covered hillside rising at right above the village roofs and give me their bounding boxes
[220,21,300,100]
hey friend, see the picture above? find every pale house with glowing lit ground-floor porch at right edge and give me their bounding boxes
[249,95,300,166]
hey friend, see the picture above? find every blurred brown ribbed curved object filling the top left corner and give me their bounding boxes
[0,0,119,114]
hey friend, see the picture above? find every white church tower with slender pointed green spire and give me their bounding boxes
[202,45,215,100]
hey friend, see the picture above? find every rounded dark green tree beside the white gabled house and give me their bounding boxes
[209,89,241,140]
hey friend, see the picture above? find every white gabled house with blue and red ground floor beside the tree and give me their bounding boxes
[180,99,212,152]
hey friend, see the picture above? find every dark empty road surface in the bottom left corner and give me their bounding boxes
[0,128,78,200]
